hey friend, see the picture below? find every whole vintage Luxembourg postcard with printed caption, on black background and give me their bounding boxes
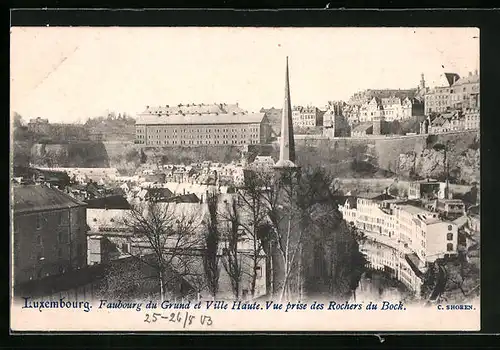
[10,27,481,332]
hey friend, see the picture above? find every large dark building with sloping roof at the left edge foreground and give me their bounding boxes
[13,185,87,284]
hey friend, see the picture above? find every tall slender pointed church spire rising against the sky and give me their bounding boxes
[276,56,295,167]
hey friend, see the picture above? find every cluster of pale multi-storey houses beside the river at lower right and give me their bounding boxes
[339,180,480,294]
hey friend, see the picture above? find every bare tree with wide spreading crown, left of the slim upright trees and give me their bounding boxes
[122,202,200,301]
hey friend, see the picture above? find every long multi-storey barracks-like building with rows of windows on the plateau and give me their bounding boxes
[135,111,271,147]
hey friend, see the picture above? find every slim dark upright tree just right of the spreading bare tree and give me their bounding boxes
[203,192,220,299]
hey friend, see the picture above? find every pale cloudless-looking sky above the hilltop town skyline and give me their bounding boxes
[11,27,479,123]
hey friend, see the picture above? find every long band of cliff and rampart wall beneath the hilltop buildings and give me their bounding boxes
[14,132,480,184]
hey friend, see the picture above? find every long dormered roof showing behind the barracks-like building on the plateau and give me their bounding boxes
[139,103,246,117]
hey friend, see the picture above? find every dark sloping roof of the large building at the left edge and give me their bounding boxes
[12,185,85,213]
